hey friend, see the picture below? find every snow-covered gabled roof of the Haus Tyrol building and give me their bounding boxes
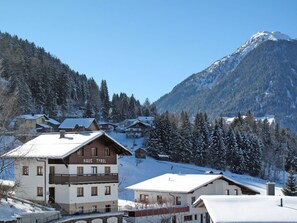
[3,131,132,159]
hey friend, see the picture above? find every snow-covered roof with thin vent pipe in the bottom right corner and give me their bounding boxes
[194,195,297,223]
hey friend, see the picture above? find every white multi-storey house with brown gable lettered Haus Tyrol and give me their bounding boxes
[3,131,132,214]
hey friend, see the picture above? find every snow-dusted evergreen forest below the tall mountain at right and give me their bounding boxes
[146,111,297,180]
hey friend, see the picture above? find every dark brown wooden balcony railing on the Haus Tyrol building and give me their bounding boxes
[49,173,119,184]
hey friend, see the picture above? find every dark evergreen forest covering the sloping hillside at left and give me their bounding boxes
[0,32,156,125]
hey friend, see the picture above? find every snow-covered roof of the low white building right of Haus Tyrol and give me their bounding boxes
[126,173,257,193]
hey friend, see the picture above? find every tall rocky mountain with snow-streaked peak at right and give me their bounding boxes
[155,32,297,131]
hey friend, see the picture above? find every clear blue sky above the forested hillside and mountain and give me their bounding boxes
[0,0,297,103]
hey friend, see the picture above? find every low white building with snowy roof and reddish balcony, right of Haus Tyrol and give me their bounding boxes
[126,174,258,223]
